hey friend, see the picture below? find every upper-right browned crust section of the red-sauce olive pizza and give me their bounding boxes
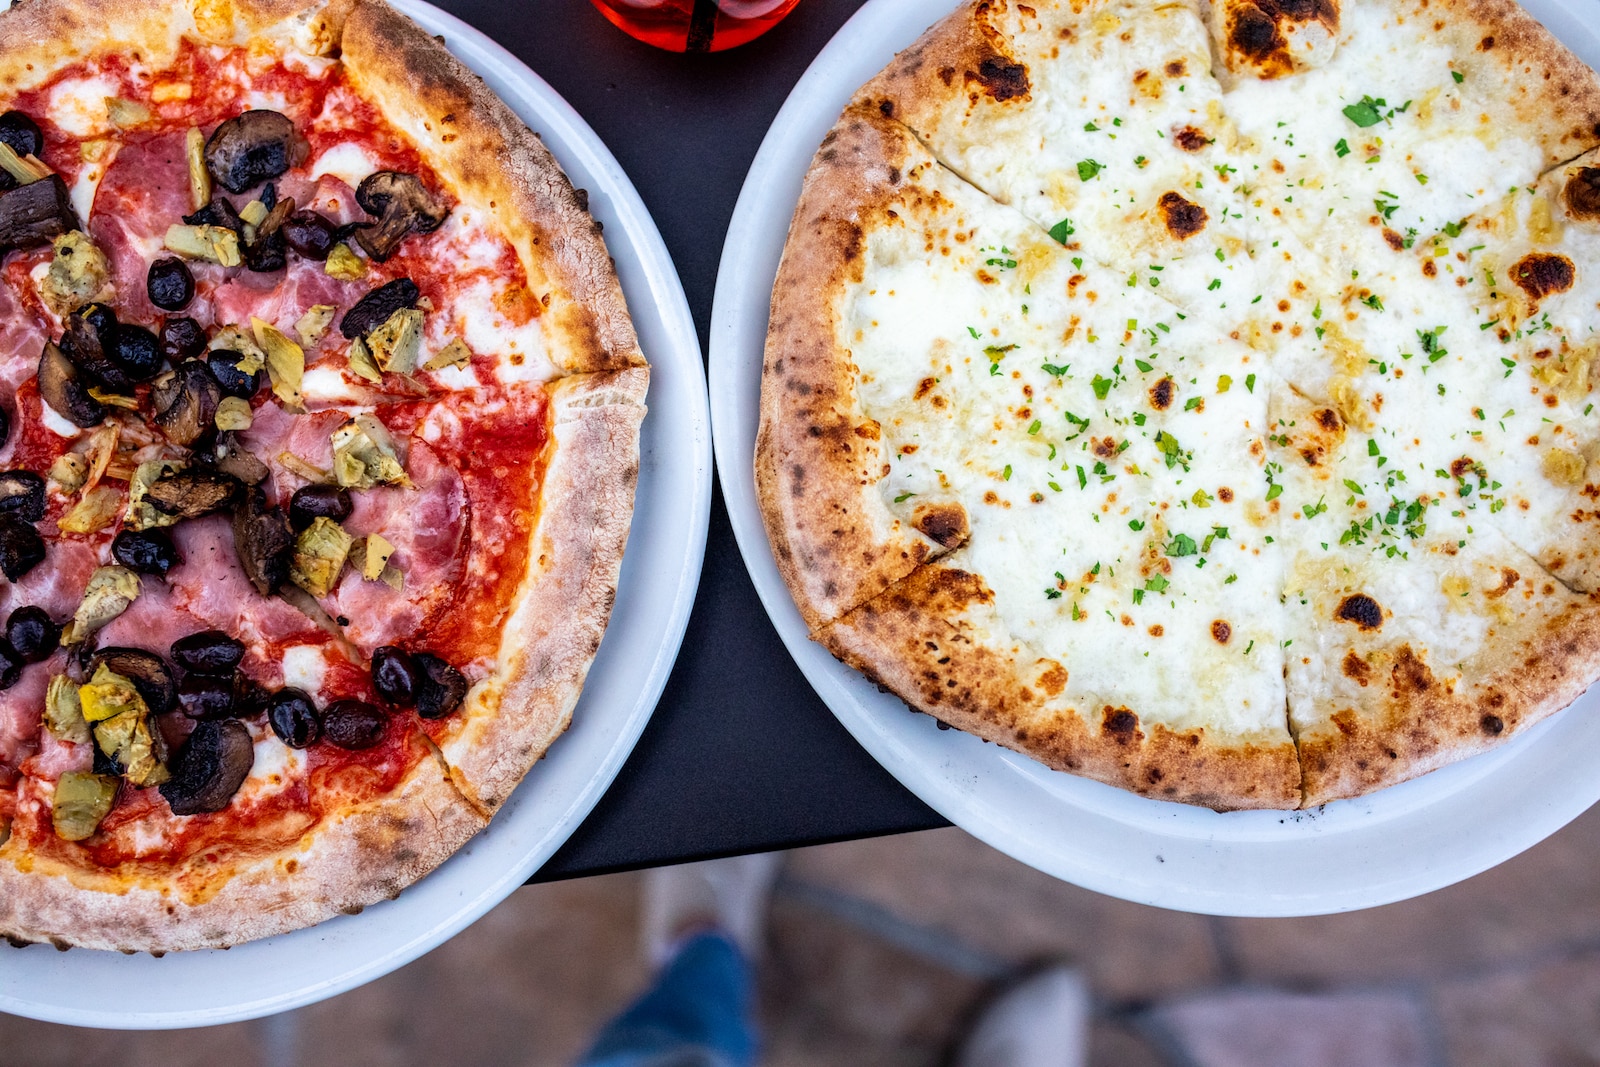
[341,0,645,373]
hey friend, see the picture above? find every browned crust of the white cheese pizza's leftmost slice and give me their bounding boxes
[755,110,965,629]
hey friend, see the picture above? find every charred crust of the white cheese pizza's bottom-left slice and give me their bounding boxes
[813,561,1301,809]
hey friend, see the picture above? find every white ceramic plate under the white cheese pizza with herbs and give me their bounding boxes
[710,0,1600,915]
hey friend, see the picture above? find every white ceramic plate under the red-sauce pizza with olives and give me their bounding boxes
[0,0,710,1029]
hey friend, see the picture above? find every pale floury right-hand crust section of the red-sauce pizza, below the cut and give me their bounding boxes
[440,368,650,813]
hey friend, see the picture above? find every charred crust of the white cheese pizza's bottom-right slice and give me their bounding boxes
[1298,560,1600,806]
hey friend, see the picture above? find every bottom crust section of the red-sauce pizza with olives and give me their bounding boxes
[0,742,488,952]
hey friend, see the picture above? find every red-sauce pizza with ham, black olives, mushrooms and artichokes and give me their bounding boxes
[0,0,648,952]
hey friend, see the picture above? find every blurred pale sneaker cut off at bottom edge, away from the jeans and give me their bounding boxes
[955,966,1090,1067]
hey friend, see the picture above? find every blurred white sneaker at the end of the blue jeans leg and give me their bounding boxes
[640,853,784,968]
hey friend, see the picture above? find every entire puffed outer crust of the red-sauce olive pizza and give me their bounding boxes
[0,0,650,952]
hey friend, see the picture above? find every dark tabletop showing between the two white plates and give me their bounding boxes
[416,0,944,880]
